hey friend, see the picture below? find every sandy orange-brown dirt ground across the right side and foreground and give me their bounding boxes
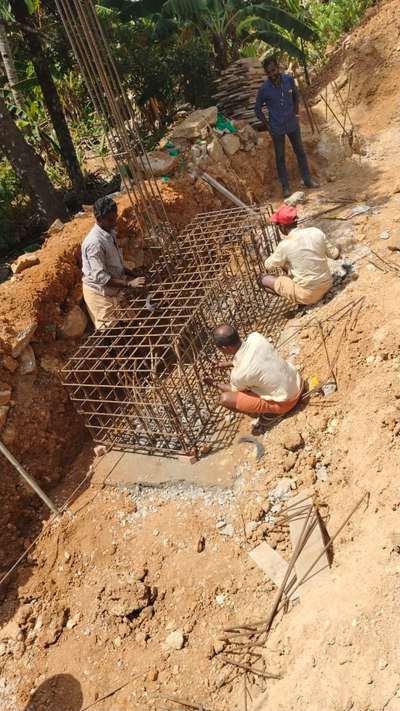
[0,0,400,711]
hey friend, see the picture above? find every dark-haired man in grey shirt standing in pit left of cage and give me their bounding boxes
[82,197,146,329]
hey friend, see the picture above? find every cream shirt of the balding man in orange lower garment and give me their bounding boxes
[231,332,301,402]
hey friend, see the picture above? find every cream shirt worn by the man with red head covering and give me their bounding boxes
[265,227,339,289]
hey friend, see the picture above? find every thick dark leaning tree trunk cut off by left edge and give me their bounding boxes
[0,95,67,224]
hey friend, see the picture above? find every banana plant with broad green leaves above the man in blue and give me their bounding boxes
[158,0,317,71]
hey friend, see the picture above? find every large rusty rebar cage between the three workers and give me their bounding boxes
[63,208,284,457]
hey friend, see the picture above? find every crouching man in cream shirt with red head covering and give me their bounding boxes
[260,205,339,304]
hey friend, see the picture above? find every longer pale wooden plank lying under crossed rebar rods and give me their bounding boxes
[289,491,329,596]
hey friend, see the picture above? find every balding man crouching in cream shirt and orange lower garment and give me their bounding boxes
[207,324,303,434]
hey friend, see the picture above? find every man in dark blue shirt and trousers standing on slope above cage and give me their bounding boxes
[256,57,318,197]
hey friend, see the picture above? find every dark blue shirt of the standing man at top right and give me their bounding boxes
[255,74,299,136]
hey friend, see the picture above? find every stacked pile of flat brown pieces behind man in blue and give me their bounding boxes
[213,58,266,128]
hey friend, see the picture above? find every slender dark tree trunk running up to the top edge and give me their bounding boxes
[10,0,83,191]
